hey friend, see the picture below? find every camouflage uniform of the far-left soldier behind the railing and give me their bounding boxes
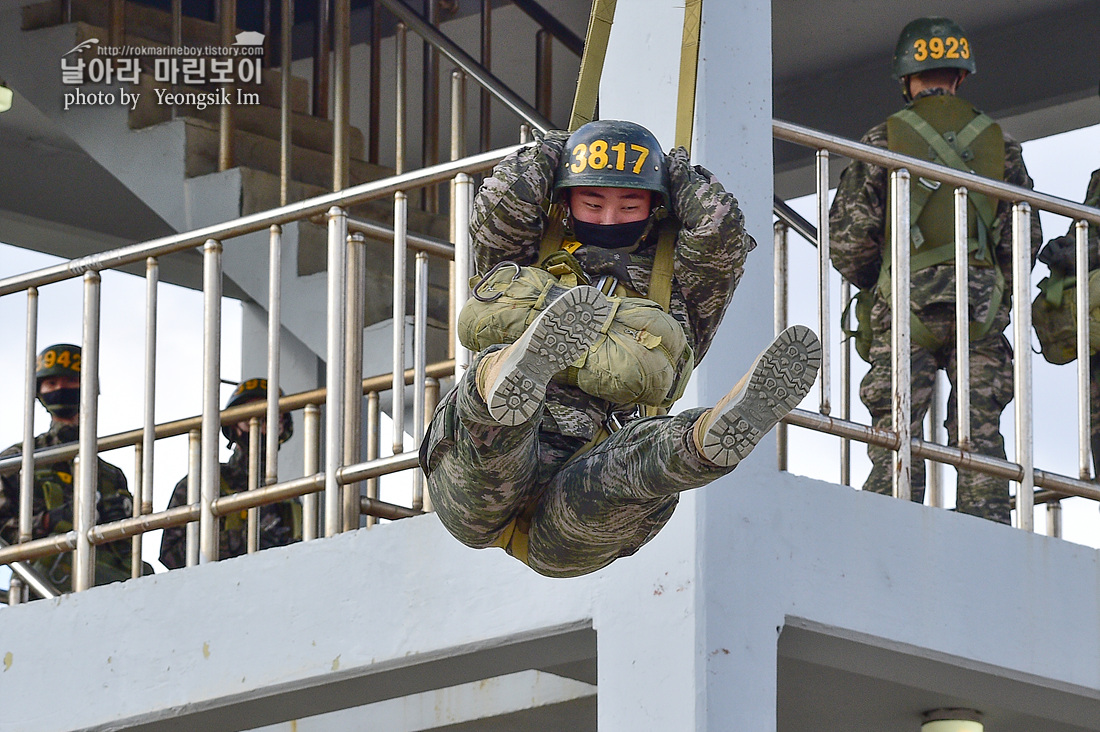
[0,422,138,592]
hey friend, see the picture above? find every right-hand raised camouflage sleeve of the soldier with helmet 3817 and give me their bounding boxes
[667,148,756,362]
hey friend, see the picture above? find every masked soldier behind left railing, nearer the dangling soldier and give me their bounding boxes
[161,379,301,569]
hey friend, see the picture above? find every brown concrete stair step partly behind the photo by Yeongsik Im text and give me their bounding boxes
[130,72,365,160]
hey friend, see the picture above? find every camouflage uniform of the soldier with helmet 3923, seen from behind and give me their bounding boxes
[829,89,1043,523]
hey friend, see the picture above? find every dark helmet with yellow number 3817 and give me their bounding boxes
[554,120,669,206]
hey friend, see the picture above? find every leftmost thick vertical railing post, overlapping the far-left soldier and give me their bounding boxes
[73,271,100,592]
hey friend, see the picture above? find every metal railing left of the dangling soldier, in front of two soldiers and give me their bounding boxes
[0,146,516,594]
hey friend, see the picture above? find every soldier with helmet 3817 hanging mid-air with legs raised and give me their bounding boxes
[420,121,821,577]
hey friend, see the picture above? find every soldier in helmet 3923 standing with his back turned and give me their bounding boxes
[829,18,1043,523]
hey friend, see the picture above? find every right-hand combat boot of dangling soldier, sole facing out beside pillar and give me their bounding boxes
[692,326,822,468]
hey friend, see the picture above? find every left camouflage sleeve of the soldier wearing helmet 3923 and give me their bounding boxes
[828,122,887,289]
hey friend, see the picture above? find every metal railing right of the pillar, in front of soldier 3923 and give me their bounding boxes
[772,120,1100,531]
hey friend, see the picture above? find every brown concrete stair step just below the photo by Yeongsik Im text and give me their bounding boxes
[183,118,393,190]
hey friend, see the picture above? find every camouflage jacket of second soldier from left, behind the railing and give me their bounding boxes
[161,447,301,569]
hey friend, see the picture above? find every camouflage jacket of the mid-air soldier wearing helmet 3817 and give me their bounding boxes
[470,131,756,439]
